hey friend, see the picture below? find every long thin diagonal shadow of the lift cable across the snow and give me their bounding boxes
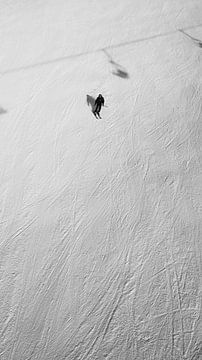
[0,24,202,76]
